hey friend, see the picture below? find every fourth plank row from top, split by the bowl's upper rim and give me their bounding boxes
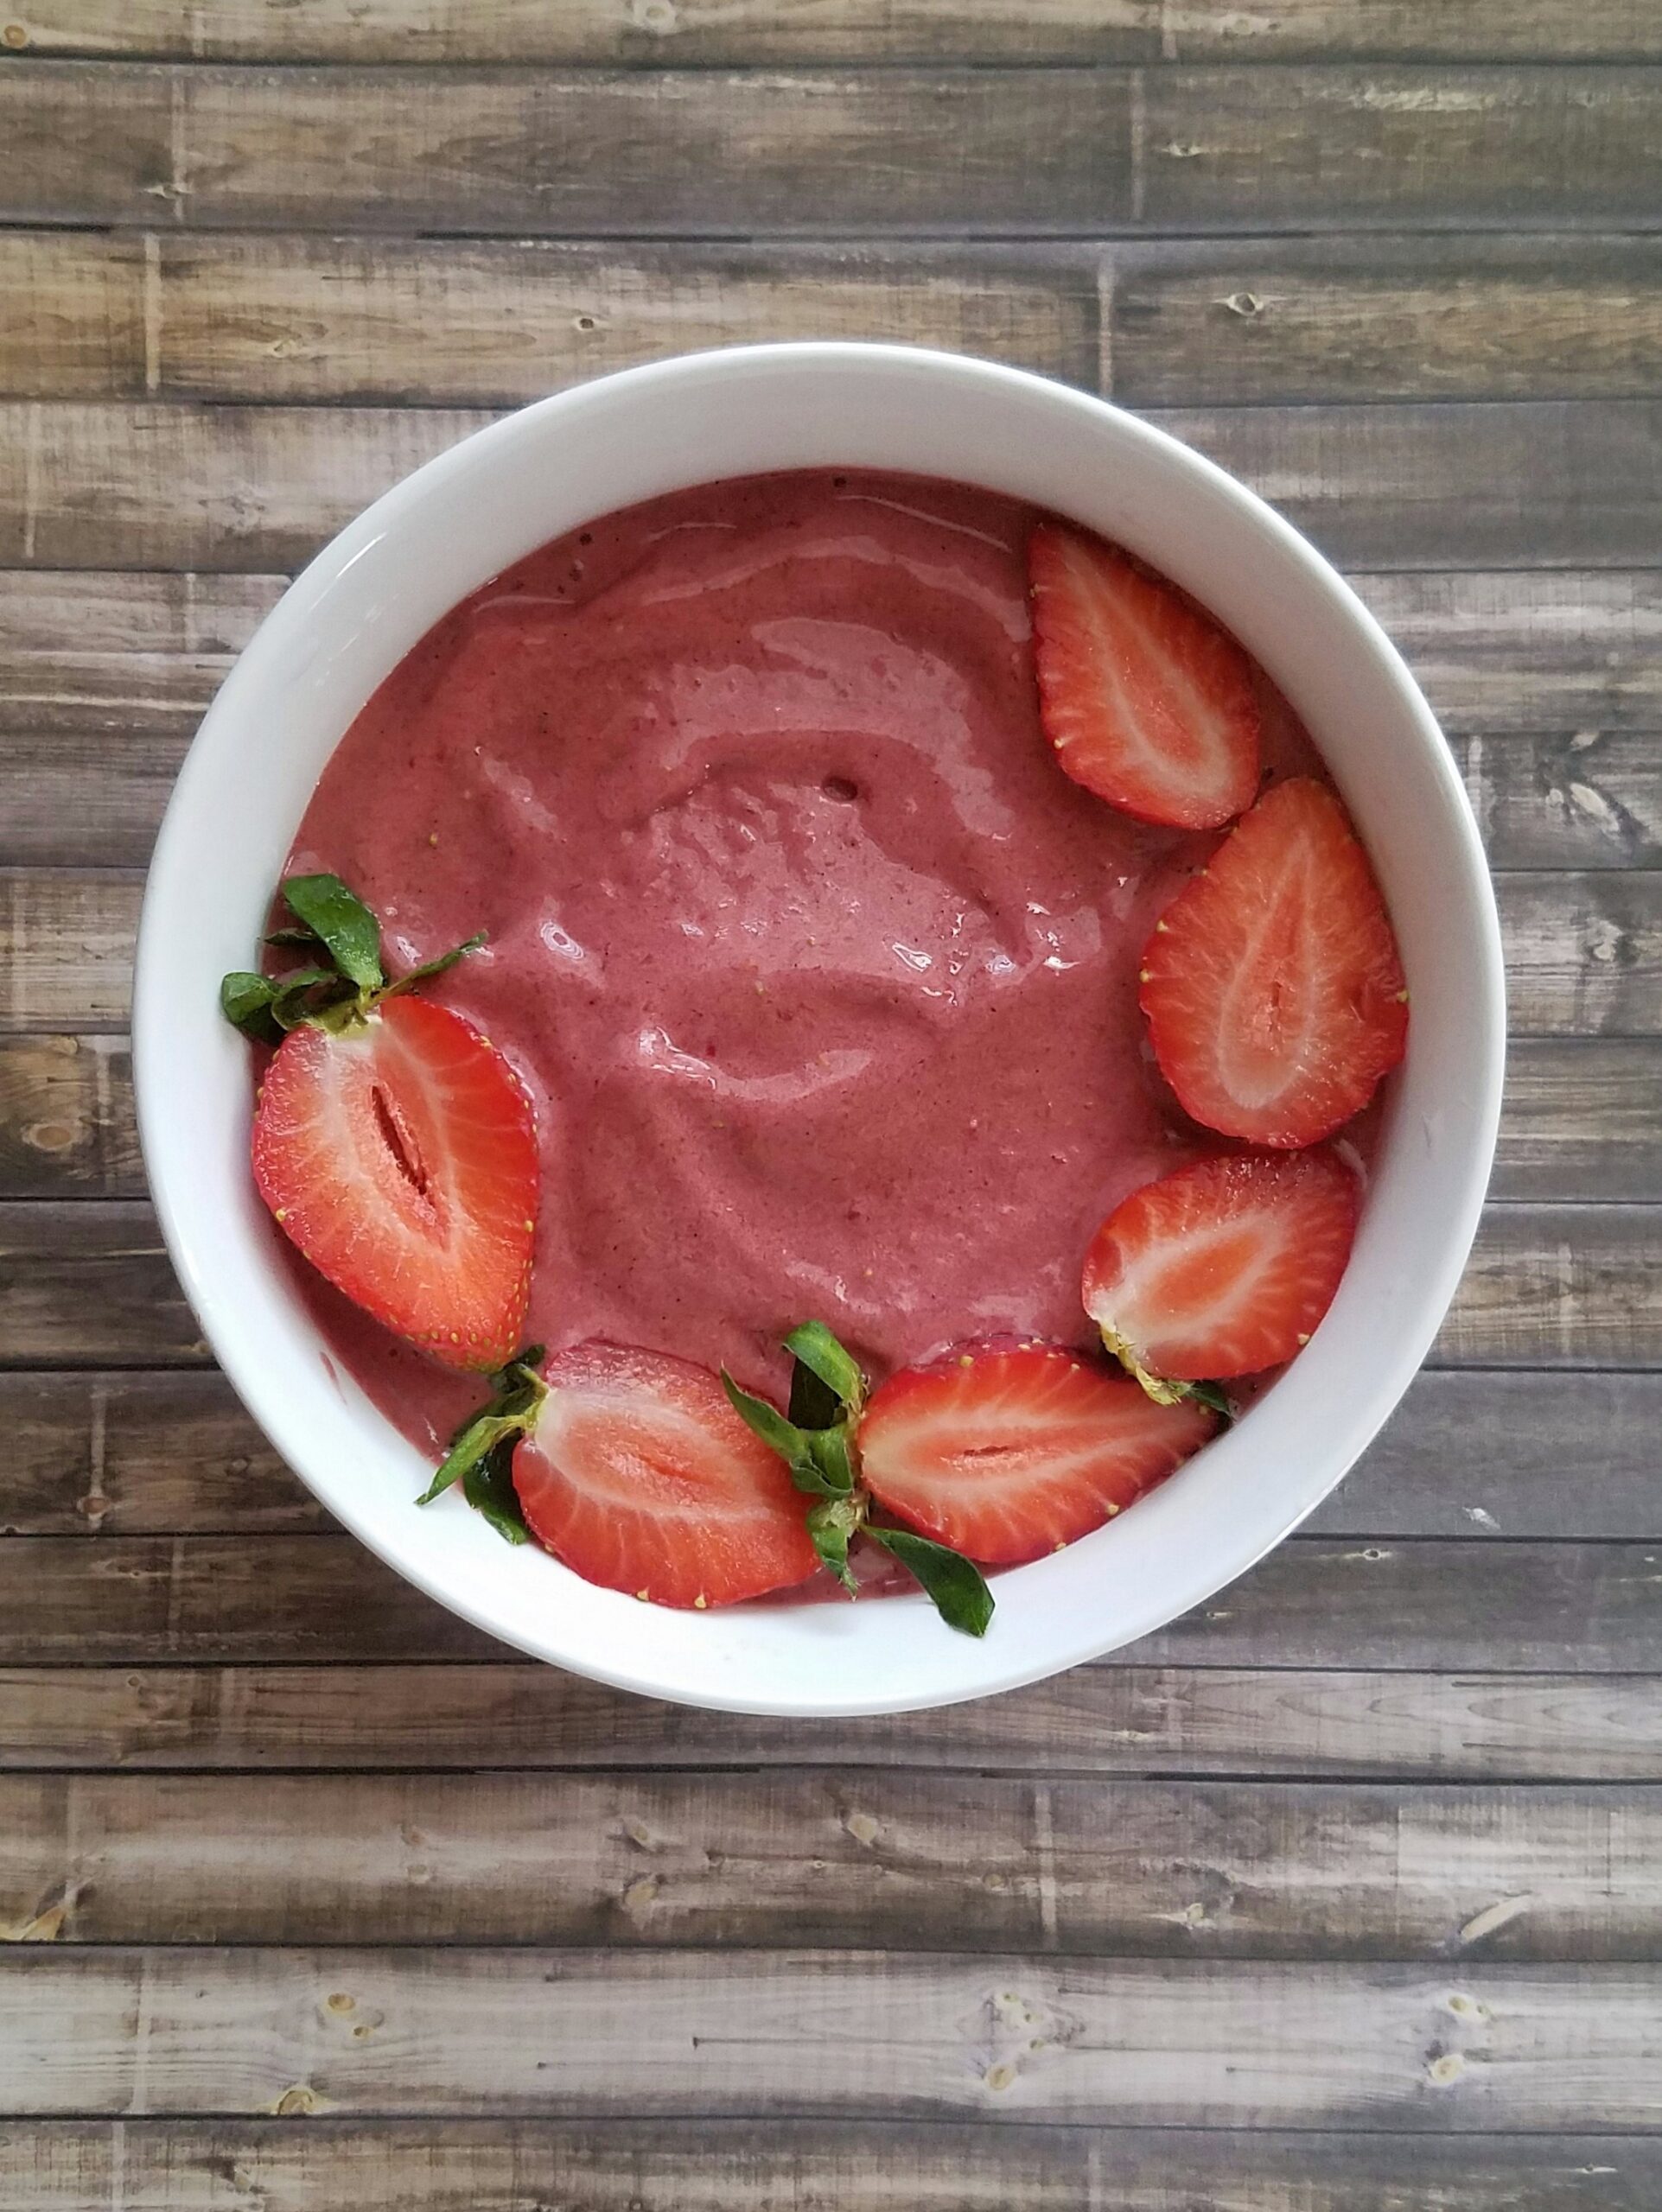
[0,400,1662,570]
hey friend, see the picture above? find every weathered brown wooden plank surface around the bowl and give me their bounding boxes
[0,0,1662,2212]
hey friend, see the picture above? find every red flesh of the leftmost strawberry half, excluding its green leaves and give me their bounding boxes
[254,998,538,1367]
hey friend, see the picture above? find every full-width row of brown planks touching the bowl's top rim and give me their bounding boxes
[19,230,1662,407]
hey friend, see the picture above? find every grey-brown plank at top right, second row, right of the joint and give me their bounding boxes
[1136,64,1662,232]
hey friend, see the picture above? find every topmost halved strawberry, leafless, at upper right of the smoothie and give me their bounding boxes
[1027,522,1259,830]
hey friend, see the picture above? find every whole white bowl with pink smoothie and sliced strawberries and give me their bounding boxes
[135,345,1503,1717]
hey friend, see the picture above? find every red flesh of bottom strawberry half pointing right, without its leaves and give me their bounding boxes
[859,1344,1215,1566]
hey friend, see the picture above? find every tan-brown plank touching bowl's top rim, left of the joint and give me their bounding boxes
[0,230,1100,407]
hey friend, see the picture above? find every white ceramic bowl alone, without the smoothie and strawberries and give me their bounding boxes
[133,345,1505,1714]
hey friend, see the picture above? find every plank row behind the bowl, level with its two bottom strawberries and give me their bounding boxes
[0,1370,1662,1541]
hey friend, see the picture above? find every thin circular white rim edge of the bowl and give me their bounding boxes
[133,340,1505,1719]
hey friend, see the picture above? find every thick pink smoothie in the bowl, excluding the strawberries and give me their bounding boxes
[292,471,1319,1442]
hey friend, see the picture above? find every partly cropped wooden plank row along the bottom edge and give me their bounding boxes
[13,2113,1662,2212]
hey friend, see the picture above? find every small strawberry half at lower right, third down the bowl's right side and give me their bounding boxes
[1085,1150,1359,1391]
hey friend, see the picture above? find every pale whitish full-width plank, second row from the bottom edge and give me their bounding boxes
[0,1944,1662,2137]
